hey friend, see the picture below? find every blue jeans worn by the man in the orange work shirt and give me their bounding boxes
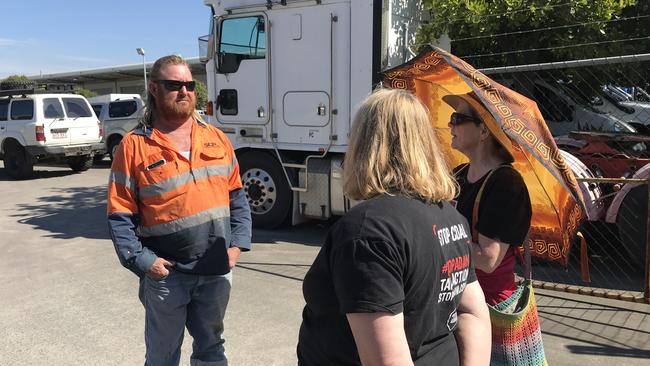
[140,269,232,366]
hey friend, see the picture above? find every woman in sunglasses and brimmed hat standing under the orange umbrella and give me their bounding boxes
[443,92,532,305]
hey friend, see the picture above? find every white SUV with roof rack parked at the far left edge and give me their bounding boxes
[0,89,105,179]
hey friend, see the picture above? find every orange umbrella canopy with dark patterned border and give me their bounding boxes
[383,46,586,266]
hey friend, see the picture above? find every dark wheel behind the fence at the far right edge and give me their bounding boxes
[616,184,648,273]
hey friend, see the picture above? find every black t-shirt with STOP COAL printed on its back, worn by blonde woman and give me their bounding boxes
[298,195,476,366]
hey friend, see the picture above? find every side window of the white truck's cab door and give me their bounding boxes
[219,16,266,73]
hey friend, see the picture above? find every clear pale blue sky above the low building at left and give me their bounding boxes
[0,0,210,80]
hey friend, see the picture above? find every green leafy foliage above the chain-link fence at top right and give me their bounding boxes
[416,0,636,67]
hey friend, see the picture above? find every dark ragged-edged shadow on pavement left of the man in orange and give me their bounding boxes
[12,185,109,239]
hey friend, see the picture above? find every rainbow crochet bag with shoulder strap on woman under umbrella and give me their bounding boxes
[472,167,548,366]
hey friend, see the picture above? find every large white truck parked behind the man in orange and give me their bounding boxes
[199,0,426,228]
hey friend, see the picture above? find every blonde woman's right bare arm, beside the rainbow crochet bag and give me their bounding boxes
[454,281,492,366]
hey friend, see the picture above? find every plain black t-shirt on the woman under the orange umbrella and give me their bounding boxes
[454,165,532,245]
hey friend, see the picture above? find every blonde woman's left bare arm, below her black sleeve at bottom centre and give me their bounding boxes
[347,312,412,366]
